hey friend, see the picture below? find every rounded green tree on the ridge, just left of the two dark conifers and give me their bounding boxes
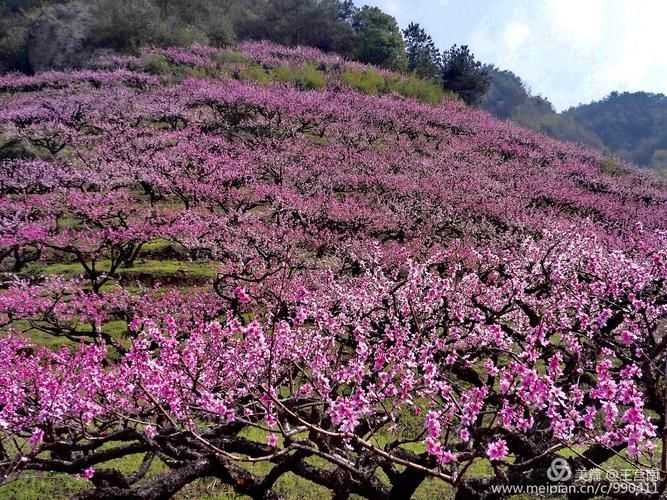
[352,5,407,71]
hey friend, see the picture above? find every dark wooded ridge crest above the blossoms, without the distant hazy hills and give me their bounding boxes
[0,0,488,103]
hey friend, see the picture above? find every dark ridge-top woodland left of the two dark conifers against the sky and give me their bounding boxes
[0,0,405,72]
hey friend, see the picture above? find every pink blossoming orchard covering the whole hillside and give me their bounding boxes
[0,44,667,498]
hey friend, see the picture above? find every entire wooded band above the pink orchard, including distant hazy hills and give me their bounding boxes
[0,0,667,170]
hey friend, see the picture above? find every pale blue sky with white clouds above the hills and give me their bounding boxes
[355,0,667,111]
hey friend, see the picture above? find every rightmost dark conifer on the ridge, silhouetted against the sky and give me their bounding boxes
[442,45,491,105]
